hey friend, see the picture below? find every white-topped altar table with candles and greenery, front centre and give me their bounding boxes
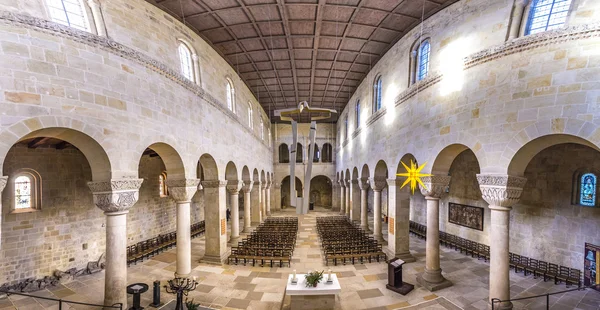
[285,273,342,310]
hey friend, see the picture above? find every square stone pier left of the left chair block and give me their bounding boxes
[202,180,229,265]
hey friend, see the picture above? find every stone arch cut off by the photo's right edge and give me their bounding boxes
[506,134,600,176]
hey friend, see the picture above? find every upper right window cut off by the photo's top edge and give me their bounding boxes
[525,0,571,35]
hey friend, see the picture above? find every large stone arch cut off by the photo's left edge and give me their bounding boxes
[0,116,113,181]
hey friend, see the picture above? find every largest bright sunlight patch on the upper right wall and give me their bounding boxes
[440,37,471,96]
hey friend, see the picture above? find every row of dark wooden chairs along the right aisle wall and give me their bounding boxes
[409,221,582,287]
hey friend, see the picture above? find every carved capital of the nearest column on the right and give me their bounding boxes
[477,174,527,210]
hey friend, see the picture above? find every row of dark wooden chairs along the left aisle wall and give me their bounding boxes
[127,221,205,266]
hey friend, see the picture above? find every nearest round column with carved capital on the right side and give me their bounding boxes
[477,174,527,309]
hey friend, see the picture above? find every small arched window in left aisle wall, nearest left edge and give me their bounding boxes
[13,169,42,212]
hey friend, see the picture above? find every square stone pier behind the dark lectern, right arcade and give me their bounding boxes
[387,179,416,263]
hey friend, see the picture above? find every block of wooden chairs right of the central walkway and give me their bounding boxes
[317,216,387,266]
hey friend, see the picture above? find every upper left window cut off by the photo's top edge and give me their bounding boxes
[46,0,90,32]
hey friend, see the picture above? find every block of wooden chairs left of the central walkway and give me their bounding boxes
[227,217,298,267]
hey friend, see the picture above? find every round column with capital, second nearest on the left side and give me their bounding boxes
[167,179,200,278]
